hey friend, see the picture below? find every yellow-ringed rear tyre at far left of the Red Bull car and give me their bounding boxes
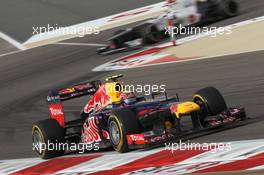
[32,119,65,159]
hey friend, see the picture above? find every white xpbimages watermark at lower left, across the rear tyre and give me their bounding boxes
[32,140,99,154]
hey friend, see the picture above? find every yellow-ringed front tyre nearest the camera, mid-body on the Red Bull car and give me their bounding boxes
[108,109,141,153]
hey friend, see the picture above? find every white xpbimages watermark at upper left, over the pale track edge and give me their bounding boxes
[32,24,100,37]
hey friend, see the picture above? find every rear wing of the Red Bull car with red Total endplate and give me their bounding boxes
[47,80,101,126]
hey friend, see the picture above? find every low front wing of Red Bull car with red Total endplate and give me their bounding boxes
[127,108,250,149]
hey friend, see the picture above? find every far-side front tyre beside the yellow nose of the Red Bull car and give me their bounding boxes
[193,87,227,116]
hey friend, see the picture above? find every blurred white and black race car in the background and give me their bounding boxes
[97,0,239,55]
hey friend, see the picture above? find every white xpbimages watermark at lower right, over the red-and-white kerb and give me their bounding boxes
[164,140,232,153]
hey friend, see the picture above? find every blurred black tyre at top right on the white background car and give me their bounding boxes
[219,0,239,18]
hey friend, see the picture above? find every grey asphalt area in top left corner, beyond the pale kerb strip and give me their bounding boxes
[0,0,160,42]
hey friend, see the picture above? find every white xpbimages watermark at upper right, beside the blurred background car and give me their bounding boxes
[164,24,232,37]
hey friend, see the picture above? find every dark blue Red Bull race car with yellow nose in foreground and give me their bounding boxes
[32,75,247,159]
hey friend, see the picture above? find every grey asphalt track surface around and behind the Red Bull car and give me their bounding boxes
[0,0,264,159]
